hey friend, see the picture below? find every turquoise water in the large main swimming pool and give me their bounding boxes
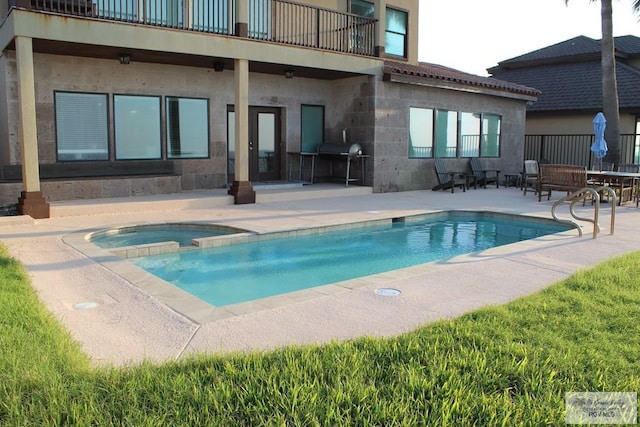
[130,215,567,306]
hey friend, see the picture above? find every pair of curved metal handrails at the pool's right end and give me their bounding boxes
[551,186,616,239]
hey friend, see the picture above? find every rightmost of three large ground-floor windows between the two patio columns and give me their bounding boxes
[165,97,209,159]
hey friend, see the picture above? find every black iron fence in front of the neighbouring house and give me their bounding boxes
[524,134,640,168]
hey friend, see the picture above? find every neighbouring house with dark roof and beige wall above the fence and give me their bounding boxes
[487,36,640,135]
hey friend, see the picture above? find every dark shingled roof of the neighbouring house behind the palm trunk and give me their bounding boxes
[489,36,640,112]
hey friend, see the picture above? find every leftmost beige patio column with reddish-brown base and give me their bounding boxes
[15,36,49,218]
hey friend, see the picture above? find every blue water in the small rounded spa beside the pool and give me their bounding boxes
[90,224,237,249]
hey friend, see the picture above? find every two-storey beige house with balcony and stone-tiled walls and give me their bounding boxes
[0,0,538,218]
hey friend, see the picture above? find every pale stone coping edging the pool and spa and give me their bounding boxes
[62,209,578,325]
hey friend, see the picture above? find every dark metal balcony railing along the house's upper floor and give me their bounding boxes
[10,0,376,57]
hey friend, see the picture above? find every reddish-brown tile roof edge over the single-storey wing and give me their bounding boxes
[384,61,539,96]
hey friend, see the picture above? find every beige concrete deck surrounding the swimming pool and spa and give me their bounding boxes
[0,184,640,365]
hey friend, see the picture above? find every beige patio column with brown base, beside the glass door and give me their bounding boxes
[229,59,256,205]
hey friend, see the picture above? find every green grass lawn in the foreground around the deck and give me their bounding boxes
[0,244,640,426]
